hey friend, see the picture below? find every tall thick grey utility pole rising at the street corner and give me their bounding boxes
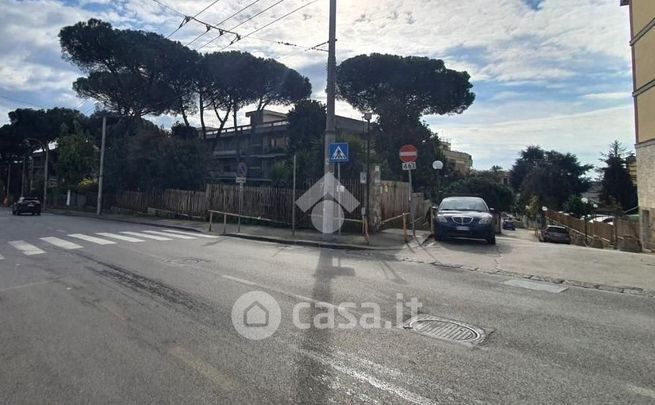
[323,0,337,237]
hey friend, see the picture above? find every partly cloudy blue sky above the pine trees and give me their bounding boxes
[0,0,634,169]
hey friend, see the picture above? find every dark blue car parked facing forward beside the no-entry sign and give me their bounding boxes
[434,197,496,245]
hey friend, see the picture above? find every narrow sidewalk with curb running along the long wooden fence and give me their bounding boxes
[48,209,429,251]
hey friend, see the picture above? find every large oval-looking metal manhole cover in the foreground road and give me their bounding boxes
[403,315,487,345]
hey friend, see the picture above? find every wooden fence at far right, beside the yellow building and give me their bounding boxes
[546,210,639,245]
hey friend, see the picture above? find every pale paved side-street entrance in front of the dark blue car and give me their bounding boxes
[422,229,655,291]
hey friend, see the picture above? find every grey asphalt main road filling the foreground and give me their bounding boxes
[0,209,655,404]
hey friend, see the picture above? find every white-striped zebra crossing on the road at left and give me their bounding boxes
[0,229,218,260]
